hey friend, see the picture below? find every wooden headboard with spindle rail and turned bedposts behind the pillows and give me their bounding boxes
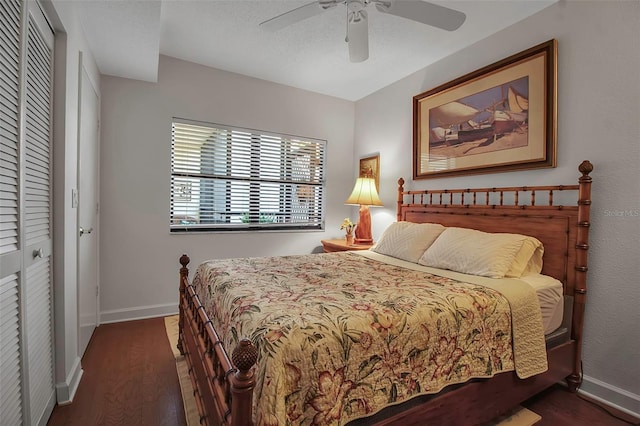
[398,161,593,386]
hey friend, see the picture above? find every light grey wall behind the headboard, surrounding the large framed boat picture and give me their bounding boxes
[355,1,640,414]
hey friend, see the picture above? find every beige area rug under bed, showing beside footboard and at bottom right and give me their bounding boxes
[164,315,542,426]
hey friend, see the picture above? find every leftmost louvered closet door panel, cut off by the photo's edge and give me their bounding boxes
[0,0,23,425]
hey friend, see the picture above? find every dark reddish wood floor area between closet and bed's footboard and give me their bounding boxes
[48,318,186,426]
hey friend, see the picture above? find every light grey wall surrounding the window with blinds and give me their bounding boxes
[100,56,354,322]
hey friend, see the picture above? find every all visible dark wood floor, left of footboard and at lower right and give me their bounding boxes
[48,318,639,426]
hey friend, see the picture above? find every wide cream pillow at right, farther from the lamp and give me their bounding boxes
[418,228,530,278]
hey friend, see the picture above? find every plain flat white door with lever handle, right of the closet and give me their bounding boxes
[78,55,99,356]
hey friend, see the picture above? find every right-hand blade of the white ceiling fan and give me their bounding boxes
[375,0,467,31]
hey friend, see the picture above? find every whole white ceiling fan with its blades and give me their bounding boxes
[260,0,466,62]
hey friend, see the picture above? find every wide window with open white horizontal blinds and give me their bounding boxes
[170,119,326,232]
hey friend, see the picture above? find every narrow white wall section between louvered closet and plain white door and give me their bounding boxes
[42,0,100,404]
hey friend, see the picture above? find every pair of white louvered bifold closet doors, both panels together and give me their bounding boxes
[0,0,55,426]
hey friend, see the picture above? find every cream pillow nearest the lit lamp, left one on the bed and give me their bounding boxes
[371,222,445,263]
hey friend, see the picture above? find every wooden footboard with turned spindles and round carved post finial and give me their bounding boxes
[178,254,258,426]
